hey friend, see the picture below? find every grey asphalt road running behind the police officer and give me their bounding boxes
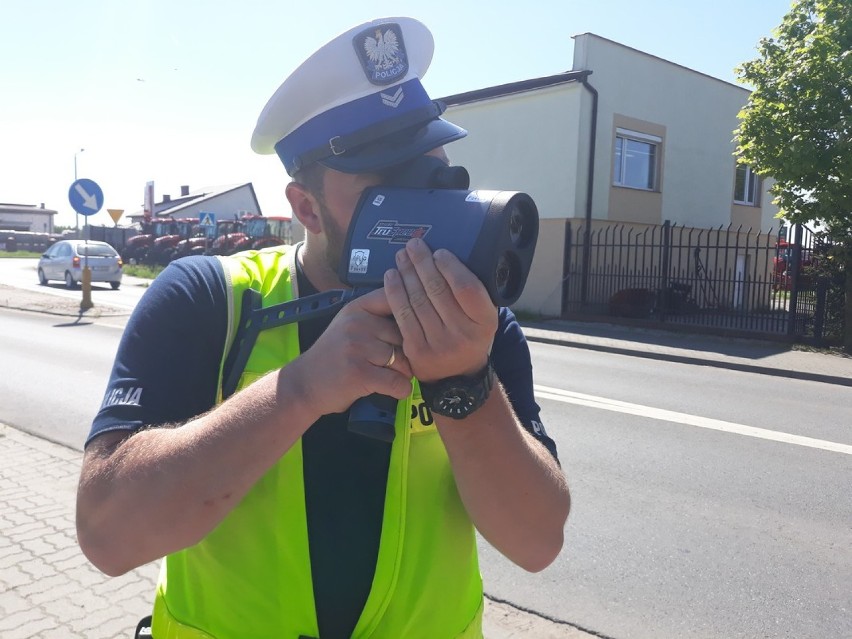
[0,258,852,639]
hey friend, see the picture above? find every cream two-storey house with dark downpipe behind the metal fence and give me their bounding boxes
[444,33,778,316]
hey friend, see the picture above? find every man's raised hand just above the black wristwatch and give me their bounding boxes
[385,239,497,382]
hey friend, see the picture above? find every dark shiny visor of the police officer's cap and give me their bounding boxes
[319,118,467,173]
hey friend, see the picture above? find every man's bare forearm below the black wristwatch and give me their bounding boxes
[438,387,570,571]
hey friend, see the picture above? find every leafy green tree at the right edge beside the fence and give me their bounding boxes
[735,0,852,351]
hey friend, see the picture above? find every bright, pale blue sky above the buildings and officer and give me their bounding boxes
[0,0,790,230]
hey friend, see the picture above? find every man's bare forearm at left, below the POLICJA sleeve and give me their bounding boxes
[77,367,318,575]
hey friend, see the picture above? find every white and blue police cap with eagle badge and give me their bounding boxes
[251,18,467,175]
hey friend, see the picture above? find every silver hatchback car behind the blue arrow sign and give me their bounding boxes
[38,240,122,289]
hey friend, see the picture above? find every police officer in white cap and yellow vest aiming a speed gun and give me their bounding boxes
[77,18,569,639]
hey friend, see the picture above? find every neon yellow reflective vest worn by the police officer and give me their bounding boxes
[152,246,483,639]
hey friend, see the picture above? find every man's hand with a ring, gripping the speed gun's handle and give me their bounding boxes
[293,289,412,415]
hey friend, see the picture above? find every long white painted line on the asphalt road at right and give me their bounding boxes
[535,384,852,455]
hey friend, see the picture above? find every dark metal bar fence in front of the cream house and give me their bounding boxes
[562,222,825,340]
